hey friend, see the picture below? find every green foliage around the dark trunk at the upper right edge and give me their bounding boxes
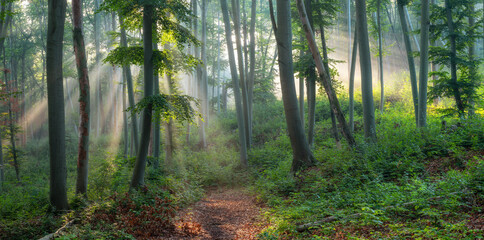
[429,0,484,115]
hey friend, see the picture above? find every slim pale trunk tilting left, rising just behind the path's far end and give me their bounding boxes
[220,0,248,168]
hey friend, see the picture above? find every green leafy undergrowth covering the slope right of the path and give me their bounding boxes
[250,98,484,239]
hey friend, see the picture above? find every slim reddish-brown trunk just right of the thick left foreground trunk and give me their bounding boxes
[72,0,90,197]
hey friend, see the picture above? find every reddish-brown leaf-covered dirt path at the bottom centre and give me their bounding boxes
[169,189,265,240]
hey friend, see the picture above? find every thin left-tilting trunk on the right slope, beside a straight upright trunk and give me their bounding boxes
[397,0,418,122]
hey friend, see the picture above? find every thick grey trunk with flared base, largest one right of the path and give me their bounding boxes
[269,0,315,172]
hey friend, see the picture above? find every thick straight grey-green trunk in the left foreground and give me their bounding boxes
[46,0,69,211]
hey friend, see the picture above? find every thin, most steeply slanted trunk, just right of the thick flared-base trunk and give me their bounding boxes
[296,0,356,146]
